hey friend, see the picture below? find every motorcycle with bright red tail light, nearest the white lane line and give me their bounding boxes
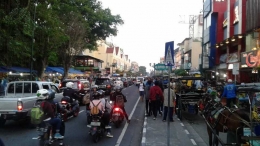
[111,106,125,128]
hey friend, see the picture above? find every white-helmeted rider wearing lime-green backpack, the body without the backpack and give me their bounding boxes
[36,89,64,139]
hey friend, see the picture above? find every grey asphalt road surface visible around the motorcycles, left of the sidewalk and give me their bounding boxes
[0,85,145,146]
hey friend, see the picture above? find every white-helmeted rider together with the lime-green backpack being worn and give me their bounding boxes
[31,89,64,139]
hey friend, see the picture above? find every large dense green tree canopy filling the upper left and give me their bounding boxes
[0,0,123,77]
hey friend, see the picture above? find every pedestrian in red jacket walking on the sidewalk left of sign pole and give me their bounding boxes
[149,81,163,120]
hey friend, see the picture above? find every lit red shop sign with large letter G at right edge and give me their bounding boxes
[241,50,260,68]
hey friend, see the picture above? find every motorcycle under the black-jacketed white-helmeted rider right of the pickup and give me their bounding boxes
[60,96,79,121]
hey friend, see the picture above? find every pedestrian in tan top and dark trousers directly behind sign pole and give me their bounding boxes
[163,84,176,122]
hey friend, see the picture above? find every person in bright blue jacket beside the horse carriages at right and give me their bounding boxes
[221,79,237,108]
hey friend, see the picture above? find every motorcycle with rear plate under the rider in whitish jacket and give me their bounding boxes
[88,115,106,143]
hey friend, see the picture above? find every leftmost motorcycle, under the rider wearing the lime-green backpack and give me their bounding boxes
[33,115,65,146]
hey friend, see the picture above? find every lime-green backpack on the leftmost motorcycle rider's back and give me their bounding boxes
[31,102,45,125]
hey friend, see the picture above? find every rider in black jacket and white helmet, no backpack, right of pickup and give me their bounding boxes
[63,82,79,111]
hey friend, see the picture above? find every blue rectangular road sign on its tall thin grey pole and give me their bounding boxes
[164,41,174,146]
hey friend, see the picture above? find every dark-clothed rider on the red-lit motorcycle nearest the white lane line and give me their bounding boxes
[110,86,130,123]
